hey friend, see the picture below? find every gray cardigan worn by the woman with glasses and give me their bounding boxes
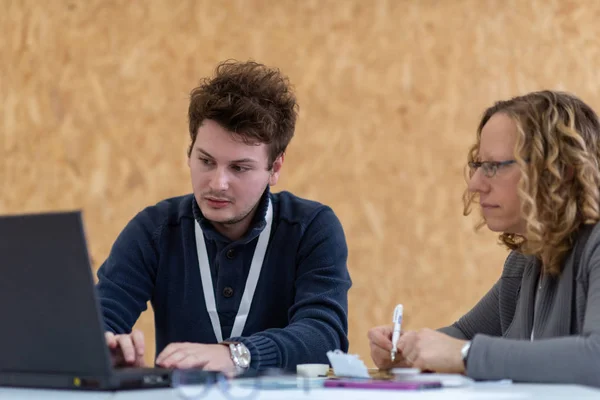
[440,223,600,387]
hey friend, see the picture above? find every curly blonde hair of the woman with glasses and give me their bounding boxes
[463,91,600,276]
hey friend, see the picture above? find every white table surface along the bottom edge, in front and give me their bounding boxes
[0,383,600,400]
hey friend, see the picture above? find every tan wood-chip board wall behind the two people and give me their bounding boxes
[0,0,600,365]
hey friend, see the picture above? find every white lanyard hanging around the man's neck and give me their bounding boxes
[195,199,273,343]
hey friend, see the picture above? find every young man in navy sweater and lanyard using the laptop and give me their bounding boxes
[97,61,351,372]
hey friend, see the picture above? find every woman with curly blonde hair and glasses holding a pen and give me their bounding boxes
[369,91,600,386]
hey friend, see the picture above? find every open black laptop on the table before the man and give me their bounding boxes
[0,211,171,390]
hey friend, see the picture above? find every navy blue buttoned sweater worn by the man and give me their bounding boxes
[97,189,351,370]
